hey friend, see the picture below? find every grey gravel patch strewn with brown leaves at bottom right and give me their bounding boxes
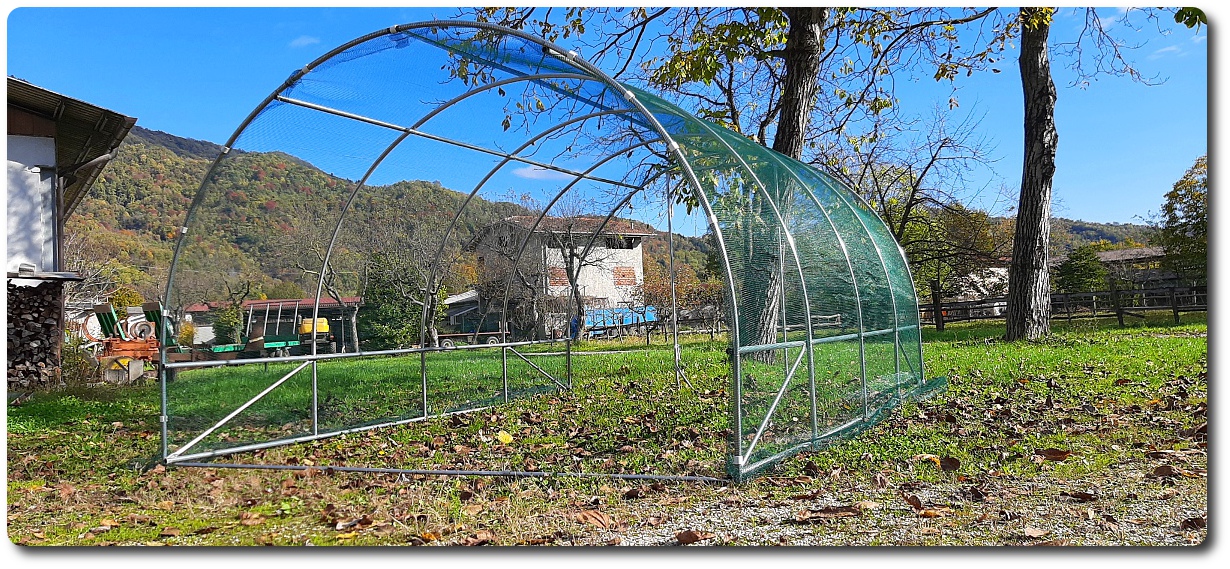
[593,472,1208,546]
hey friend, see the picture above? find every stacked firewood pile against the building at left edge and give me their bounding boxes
[9,280,64,392]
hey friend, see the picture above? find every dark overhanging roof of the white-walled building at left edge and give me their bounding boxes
[9,77,137,219]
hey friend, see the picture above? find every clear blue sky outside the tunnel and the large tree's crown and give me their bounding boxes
[5,7,1215,227]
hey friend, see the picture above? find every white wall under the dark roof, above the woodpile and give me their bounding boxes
[5,135,60,272]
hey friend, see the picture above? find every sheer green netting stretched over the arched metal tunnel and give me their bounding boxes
[164,22,935,479]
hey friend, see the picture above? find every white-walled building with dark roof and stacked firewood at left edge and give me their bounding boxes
[5,77,137,390]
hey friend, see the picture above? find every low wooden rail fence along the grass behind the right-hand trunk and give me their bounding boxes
[919,286,1209,326]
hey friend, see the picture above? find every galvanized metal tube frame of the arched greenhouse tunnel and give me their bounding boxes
[159,21,945,482]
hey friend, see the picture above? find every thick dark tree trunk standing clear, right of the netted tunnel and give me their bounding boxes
[1005,9,1059,340]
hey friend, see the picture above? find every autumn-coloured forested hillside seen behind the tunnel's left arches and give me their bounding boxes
[65,127,707,301]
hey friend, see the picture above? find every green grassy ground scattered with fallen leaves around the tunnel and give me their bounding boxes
[7,315,1208,544]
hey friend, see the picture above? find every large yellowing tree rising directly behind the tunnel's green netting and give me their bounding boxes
[464,7,999,354]
